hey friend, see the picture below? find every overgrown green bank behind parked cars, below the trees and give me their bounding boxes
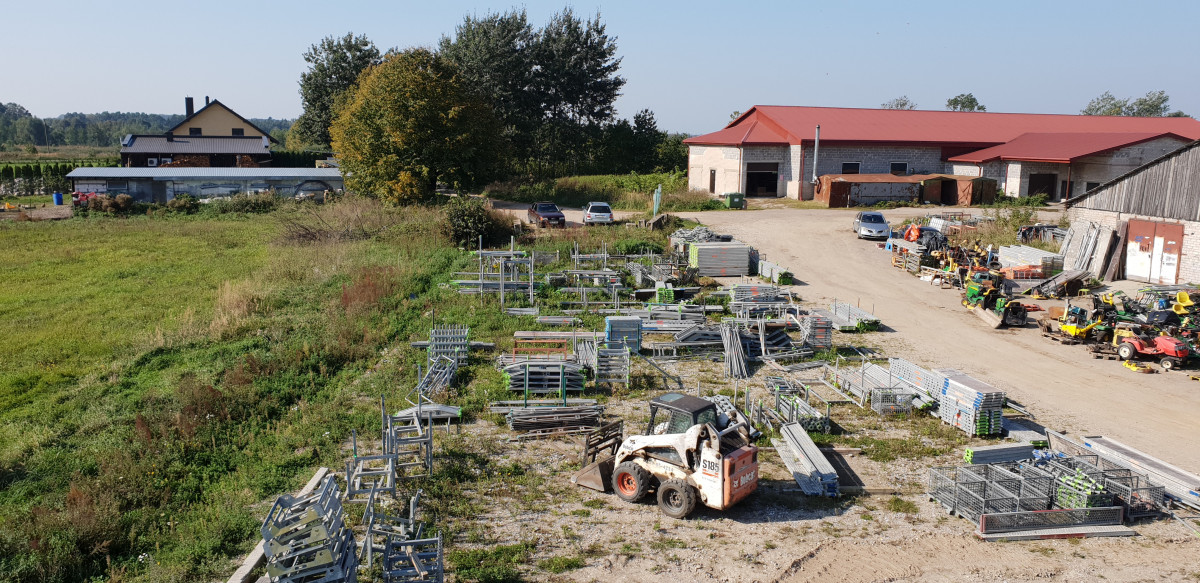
[486,173,724,212]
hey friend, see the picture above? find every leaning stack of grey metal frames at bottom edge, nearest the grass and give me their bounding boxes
[260,476,359,583]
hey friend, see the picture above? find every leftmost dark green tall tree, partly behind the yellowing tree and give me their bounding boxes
[288,32,379,148]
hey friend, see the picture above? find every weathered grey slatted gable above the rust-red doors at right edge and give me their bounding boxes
[1072,145,1200,221]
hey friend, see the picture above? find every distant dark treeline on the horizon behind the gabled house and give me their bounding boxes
[0,103,293,149]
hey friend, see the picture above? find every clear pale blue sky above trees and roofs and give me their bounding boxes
[0,0,1200,133]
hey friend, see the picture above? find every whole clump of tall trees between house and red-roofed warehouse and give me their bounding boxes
[287,8,688,202]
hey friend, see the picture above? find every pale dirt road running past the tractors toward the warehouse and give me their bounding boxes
[682,209,1200,473]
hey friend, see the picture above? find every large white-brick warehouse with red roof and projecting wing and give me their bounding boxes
[684,106,1200,200]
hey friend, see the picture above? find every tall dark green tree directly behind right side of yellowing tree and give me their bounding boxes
[438,10,541,151]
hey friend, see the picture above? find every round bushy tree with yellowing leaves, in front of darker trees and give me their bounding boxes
[330,49,502,204]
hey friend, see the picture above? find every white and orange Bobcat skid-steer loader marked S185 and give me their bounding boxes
[571,392,758,518]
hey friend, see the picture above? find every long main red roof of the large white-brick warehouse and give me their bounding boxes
[684,106,1200,148]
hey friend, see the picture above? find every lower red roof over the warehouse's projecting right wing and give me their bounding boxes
[948,132,1189,164]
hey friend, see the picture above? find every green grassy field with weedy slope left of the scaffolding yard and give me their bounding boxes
[0,200,660,582]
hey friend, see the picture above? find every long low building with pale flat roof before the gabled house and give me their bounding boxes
[67,168,344,203]
